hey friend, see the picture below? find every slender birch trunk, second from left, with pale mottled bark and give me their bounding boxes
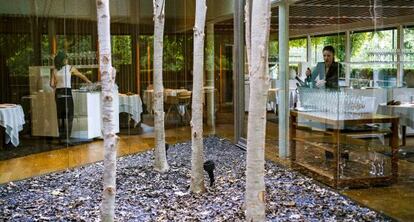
[153,0,169,172]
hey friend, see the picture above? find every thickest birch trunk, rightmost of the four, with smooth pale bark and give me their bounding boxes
[246,0,270,221]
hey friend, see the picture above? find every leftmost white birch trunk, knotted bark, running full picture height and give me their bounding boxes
[96,0,118,221]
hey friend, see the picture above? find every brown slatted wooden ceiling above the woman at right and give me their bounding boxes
[216,0,414,35]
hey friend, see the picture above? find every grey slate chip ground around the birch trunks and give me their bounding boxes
[0,137,390,221]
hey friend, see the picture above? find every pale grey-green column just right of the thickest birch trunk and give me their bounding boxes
[278,0,289,158]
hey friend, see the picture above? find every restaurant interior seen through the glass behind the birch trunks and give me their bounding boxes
[0,0,414,221]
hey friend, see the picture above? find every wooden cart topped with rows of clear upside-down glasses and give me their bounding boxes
[290,87,399,187]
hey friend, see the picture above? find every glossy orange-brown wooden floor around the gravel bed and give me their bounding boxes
[0,117,414,221]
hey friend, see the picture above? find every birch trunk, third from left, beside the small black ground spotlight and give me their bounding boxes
[190,0,207,193]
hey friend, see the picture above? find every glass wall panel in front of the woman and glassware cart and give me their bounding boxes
[284,1,412,191]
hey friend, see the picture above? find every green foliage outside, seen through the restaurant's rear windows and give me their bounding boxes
[0,28,414,81]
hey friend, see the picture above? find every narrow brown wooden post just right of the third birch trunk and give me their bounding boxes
[204,23,215,126]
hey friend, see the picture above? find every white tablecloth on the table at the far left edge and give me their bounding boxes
[0,104,24,146]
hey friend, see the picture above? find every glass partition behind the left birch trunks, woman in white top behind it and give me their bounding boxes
[0,0,226,183]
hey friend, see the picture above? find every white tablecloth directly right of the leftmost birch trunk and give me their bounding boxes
[119,94,142,127]
